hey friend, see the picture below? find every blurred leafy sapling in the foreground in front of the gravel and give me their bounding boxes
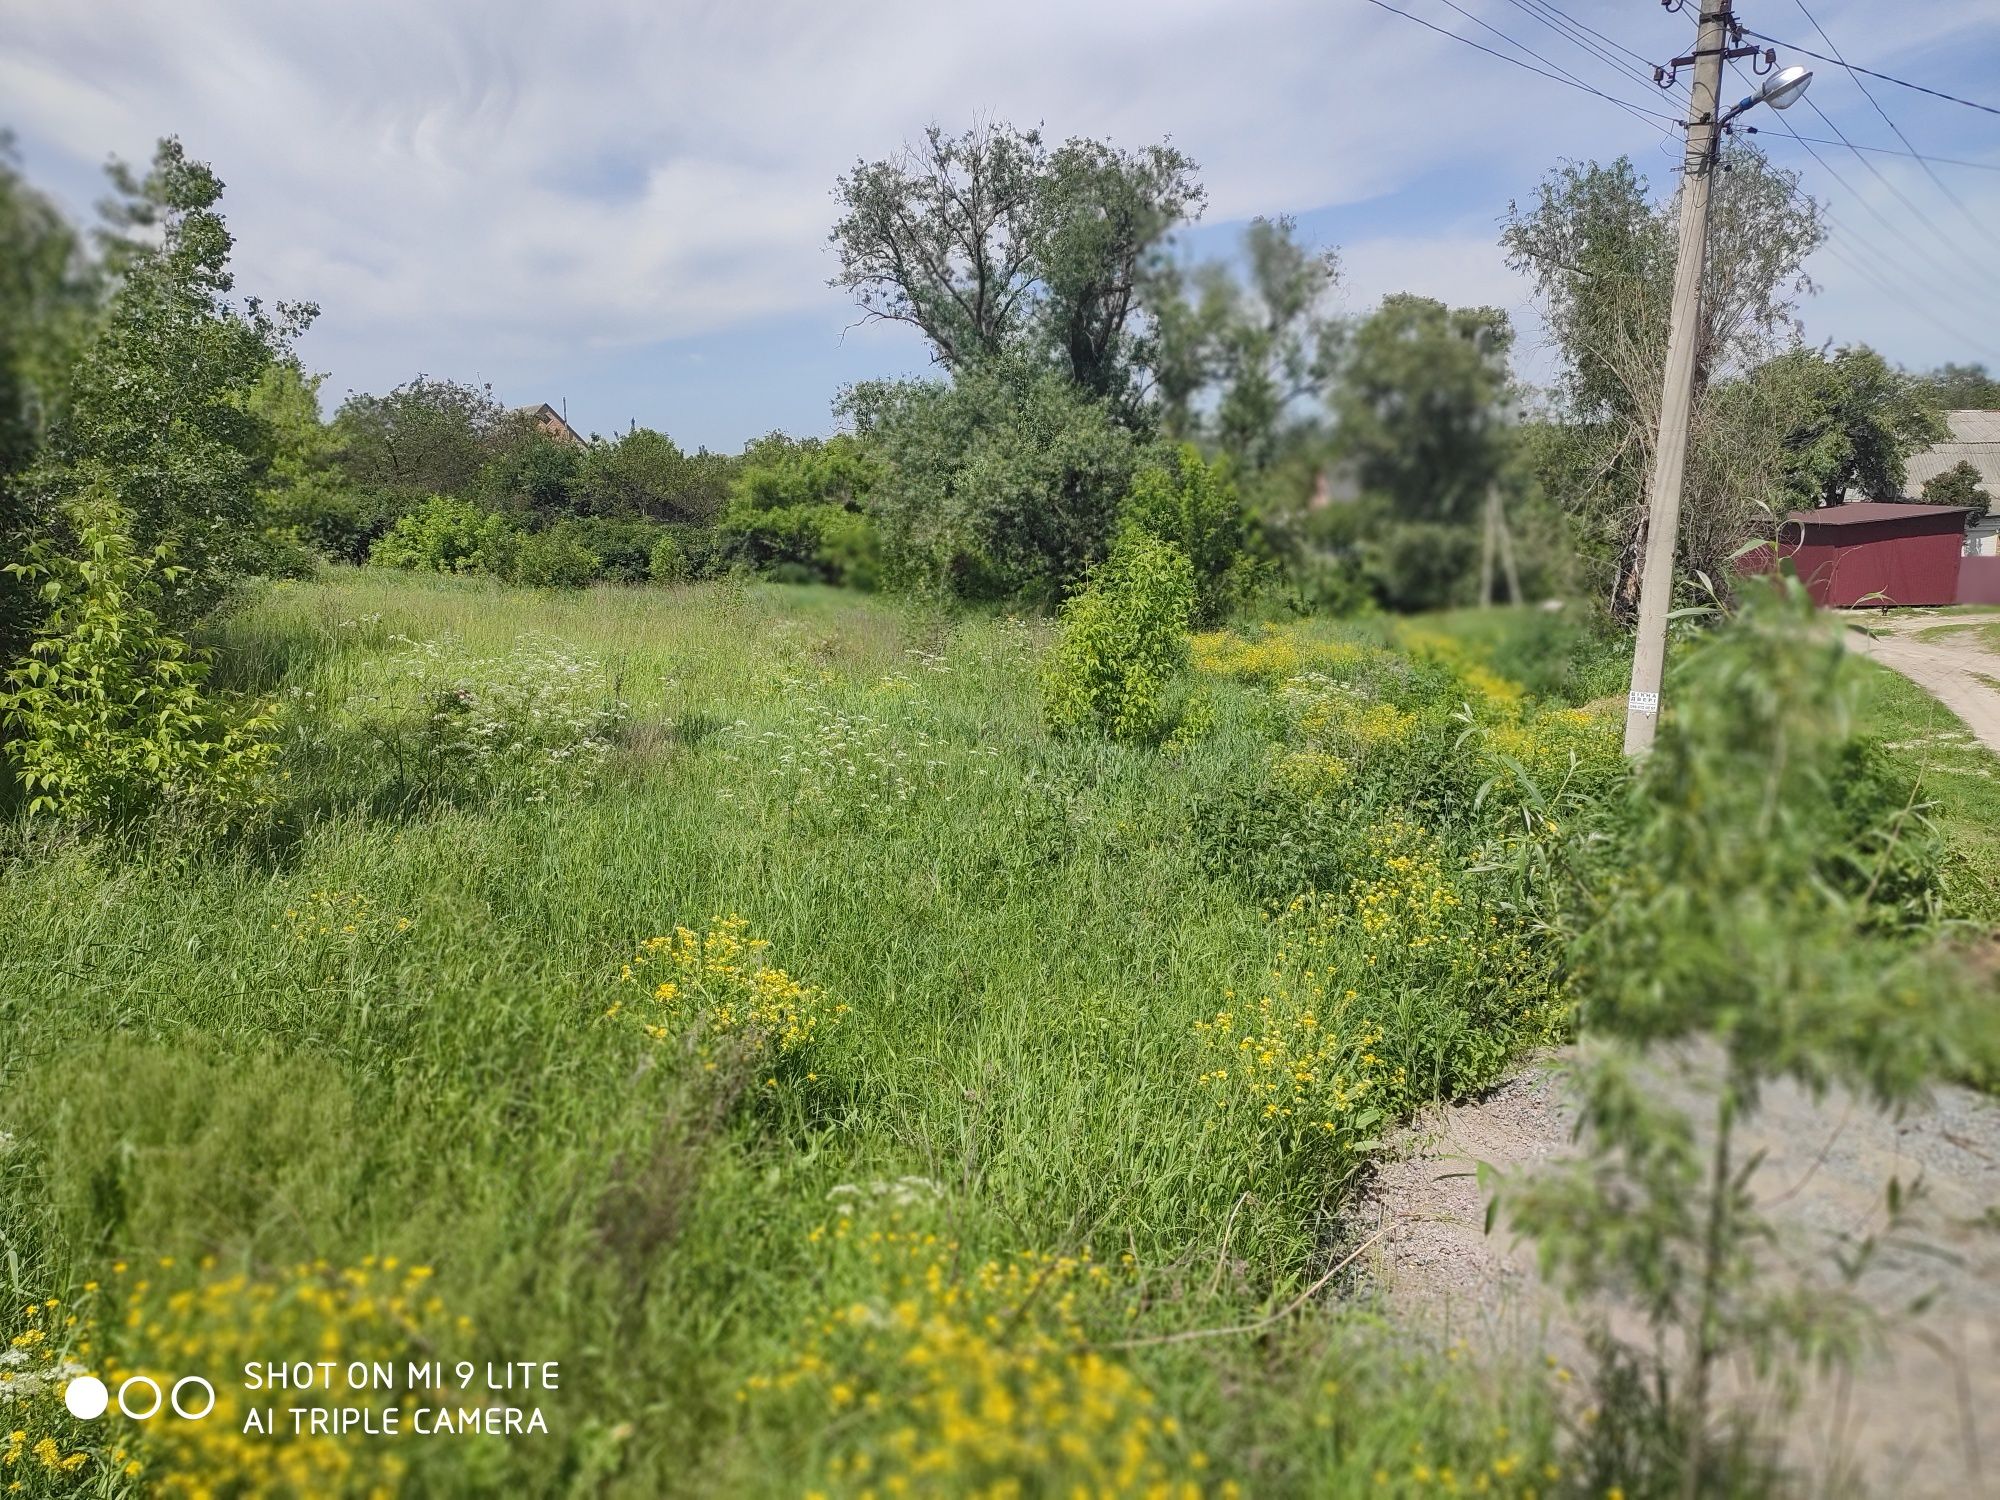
[1496,580,1982,1496]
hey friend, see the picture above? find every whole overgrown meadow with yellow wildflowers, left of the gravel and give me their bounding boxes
[0,574,1606,1494]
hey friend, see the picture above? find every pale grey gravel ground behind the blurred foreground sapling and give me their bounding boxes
[1360,1058,2000,1496]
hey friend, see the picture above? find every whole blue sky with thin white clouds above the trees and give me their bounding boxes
[0,0,2000,450]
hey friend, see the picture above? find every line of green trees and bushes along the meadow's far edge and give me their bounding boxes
[0,124,2000,828]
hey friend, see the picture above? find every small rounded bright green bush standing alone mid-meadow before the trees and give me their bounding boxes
[1042,530,1194,740]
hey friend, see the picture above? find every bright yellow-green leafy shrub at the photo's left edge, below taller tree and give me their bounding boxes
[0,512,278,830]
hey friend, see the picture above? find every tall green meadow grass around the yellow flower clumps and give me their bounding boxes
[0,572,1608,1494]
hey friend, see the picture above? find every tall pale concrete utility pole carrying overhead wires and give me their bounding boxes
[1626,0,1732,756]
